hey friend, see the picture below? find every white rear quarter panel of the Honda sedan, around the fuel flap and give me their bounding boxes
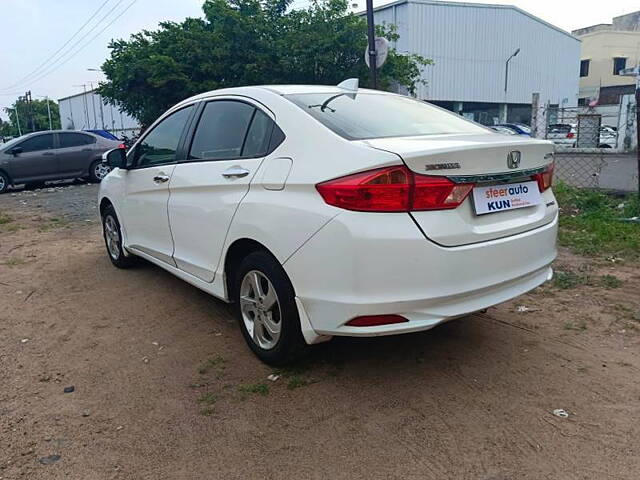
[217,89,402,285]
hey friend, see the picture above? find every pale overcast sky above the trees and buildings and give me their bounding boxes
[0,0,639,119]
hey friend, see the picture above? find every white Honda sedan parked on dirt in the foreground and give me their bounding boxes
[99,84,558,364]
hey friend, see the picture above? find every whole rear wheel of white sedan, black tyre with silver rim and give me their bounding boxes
[233,251,306,365]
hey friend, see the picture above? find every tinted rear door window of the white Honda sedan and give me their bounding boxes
[188,100,255,160]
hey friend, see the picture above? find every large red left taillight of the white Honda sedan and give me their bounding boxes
[316,166,473,212]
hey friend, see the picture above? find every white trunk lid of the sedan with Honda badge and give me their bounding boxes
[360,133,557,247]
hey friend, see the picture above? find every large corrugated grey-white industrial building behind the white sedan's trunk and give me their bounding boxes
[374,0,580,125]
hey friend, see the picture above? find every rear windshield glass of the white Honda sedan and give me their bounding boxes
[285,93,488,140]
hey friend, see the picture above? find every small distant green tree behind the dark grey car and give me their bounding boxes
[0,98,60,137]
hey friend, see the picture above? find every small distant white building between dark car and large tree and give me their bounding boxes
[58,90,140,137]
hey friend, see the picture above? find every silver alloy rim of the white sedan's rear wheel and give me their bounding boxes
[240,270,282,350]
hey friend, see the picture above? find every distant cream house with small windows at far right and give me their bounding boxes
[572,11,640,105]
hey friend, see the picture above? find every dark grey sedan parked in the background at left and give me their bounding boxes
[0,130,124,193]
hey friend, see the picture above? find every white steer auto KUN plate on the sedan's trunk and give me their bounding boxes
[473,182,542,215]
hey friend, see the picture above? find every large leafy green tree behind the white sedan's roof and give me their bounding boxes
[100,0,431,125]
